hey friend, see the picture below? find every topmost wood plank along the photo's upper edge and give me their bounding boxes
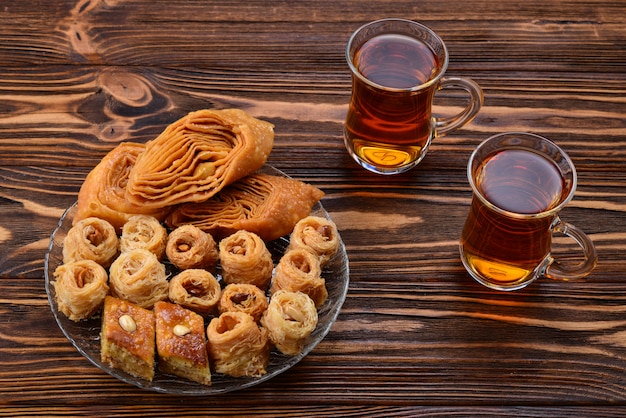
[0,0,625,71]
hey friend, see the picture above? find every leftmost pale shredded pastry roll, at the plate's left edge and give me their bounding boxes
[52,260,109,321]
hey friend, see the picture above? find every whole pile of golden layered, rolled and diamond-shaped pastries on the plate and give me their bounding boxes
[53,109,339,385]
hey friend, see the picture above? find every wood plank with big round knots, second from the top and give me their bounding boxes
[0,66,626,169]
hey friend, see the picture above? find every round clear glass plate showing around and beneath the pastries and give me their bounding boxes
[45,166,349,395]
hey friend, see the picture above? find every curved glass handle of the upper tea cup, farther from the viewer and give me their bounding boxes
[435,77,485,136]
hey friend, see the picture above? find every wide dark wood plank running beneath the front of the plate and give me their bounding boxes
[0,280,626,407]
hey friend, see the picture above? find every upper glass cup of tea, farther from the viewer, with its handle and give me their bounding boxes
[344,19,483,174]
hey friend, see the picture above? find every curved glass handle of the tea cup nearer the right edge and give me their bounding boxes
[544,217,598,280]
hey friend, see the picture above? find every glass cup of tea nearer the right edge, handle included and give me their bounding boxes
[460,132,597,290]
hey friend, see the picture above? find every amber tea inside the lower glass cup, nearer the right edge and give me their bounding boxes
[461,149,563,283]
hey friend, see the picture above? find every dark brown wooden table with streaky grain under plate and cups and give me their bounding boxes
[0,0,626,417]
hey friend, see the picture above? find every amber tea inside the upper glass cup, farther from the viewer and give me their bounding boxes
[346,35,438,167]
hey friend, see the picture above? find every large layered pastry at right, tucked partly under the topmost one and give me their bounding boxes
[166,173,324,241]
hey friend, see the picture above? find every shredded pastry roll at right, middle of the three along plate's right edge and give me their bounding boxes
[271,248,328,307]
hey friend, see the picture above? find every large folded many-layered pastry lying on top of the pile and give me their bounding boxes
[126,109,274,208]
